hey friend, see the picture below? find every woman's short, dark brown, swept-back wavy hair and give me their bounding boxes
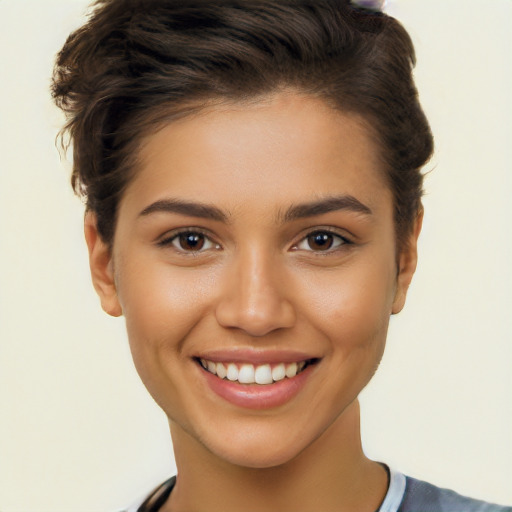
[52,0,433,248]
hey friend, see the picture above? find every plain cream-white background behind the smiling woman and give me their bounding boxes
[0,0,512,512]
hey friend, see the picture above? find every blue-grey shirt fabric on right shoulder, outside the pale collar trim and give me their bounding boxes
[398,477,512,512]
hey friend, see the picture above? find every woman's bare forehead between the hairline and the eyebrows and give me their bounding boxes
[121,93,391,218]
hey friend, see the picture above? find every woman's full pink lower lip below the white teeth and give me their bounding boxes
[199,365,316,409]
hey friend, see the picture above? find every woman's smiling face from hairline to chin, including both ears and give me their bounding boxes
[86,93,415,467]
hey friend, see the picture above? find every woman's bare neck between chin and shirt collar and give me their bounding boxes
[162,401,387,512]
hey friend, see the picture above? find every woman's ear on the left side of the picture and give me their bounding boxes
[84,212,123,316]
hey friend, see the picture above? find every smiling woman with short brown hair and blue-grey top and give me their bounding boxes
[53,0,510,512]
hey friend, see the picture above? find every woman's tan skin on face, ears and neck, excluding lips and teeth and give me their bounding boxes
[85,92,421,512]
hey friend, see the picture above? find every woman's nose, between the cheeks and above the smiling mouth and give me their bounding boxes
[216,250,296,336]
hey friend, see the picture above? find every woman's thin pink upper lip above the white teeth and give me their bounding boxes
[196,348,320,365]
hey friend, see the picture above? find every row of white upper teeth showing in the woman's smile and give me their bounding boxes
[199,359,307,385]
